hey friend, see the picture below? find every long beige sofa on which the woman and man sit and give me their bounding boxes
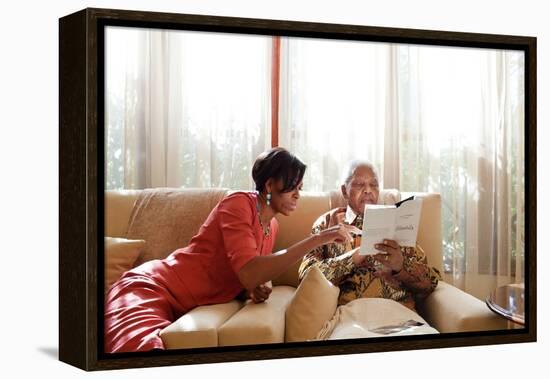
[105,189,507,349]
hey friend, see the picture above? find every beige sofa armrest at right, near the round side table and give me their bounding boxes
[418,281,508,333]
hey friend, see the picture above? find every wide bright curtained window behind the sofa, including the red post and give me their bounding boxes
[106,27,524,284]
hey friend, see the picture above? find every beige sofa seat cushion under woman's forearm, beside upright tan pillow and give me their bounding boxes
[218,286,295,346]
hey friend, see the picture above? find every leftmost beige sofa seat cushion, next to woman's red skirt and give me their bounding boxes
[160,300,244,349]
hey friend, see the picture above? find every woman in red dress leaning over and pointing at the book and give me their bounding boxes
[105,148,360,353]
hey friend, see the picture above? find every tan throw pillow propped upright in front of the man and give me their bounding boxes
[285,266,340,342]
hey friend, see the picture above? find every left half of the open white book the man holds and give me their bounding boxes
[359,204,397,255]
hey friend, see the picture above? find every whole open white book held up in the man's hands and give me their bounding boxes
[360,196,422,255]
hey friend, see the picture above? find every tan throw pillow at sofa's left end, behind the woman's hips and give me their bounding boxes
[104,237,146,292]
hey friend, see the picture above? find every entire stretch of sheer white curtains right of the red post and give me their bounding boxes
[280,38,524,298]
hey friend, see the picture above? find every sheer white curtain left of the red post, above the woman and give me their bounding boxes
[105,27,271,189]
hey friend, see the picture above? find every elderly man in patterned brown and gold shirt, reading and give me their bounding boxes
[299,161,440,310]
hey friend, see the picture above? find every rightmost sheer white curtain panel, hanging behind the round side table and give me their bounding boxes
[398,46,525,298]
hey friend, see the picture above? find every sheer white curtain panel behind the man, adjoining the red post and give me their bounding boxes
[279,38,399,191]
